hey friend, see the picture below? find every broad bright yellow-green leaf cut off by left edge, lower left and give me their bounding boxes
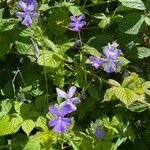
[0,115,23,136]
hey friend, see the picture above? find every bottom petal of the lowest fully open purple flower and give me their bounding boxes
[53,121,67,133]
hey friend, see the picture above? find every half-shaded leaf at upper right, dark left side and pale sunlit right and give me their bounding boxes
[119,13,144,34]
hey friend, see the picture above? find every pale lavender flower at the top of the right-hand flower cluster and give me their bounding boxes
[103,43,122,59]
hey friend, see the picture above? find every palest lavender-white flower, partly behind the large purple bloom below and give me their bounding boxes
[56,86,81,112]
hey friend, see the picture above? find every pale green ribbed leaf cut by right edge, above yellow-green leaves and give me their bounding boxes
[137,47,150,59]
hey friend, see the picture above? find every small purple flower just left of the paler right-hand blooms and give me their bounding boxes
[89,55,104,69]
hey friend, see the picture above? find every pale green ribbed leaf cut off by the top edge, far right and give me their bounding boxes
[119,0,146,10]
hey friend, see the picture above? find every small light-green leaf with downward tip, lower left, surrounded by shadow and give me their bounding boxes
[21,119,35,136]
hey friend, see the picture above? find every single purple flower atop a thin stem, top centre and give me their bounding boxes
[69,14,86,31]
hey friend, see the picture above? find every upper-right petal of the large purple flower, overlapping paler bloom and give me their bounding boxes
[59,104,72,117]
